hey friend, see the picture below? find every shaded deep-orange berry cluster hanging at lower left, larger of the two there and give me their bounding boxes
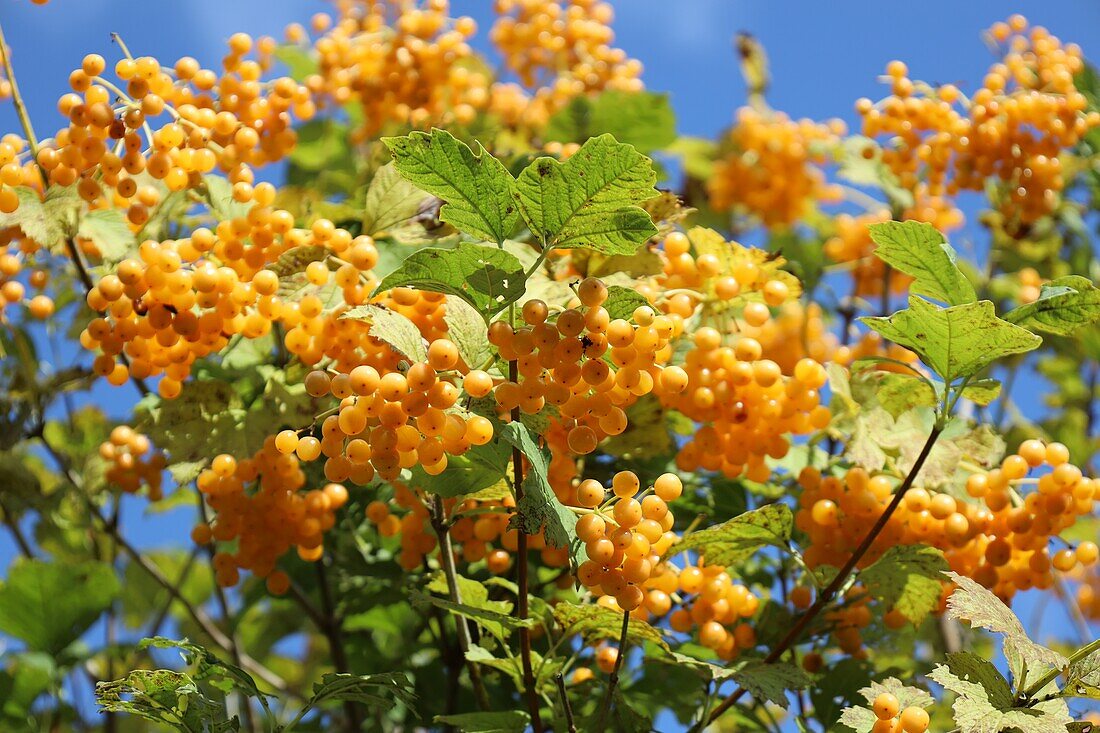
[191,436,348,594]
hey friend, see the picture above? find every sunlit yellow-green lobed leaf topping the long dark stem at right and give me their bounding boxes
[860,296,1043,384]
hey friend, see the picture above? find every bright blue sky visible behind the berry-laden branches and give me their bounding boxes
[0,0,1100,726]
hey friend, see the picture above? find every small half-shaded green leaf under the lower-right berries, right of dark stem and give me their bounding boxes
[859,545,947,625]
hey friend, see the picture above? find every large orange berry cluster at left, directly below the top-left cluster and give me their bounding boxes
[80,208,377,398]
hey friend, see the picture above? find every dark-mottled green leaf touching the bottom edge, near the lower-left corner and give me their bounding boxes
[96,669,240,733]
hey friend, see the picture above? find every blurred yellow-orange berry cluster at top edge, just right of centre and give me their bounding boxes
[490,0,642,125]
